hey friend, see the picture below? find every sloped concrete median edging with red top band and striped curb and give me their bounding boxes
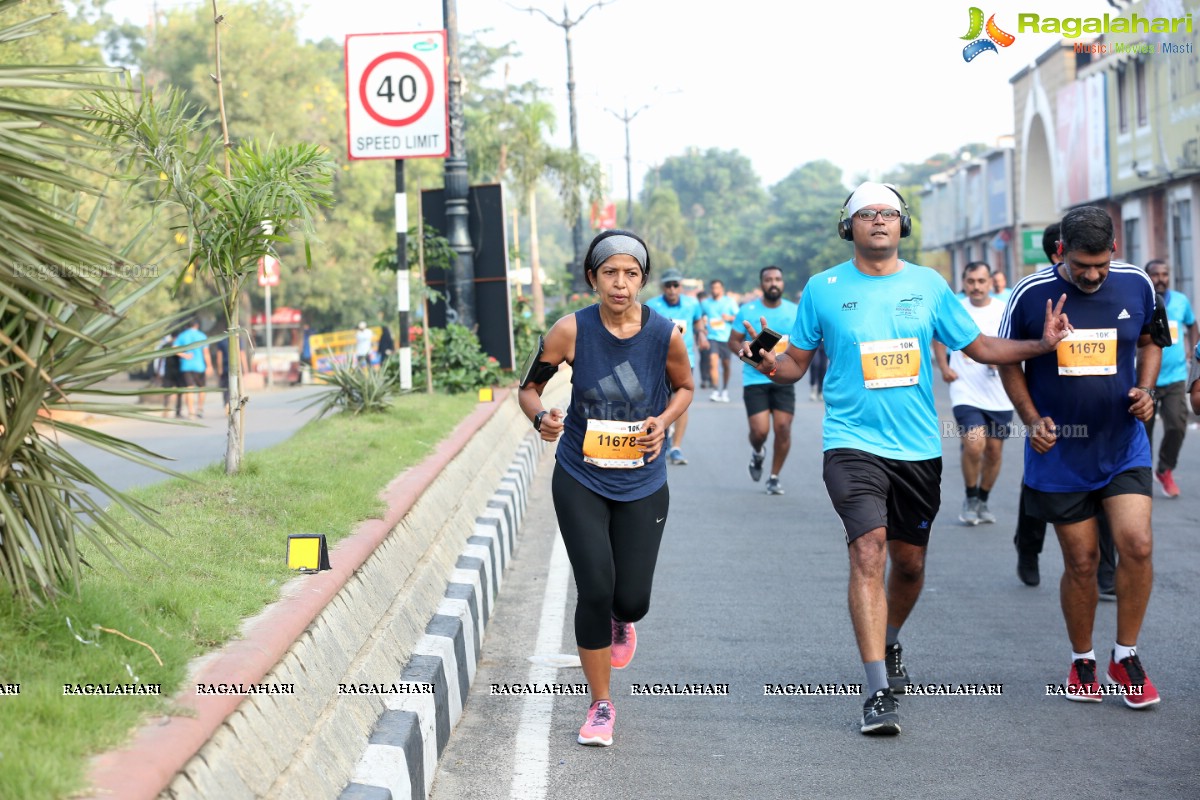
[90,390,561,800]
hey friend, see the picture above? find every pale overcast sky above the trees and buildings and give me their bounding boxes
[100,0,1171,198]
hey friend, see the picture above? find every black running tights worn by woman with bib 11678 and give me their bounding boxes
[552,464,671,650]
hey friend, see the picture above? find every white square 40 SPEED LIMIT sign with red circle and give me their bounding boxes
[346,30,450,158]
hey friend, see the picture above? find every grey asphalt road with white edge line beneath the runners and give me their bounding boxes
[432,367,1200,800]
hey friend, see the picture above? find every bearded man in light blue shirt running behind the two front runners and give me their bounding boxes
[730,266,797,494]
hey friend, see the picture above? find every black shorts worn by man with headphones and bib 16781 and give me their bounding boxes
[823,447,942,547]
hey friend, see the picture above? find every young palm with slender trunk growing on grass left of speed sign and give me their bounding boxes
[96,79,332,474]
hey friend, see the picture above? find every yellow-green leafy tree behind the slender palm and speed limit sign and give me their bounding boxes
[142,0,388,330]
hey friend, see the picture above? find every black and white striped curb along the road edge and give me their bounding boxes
[338,437,546,800]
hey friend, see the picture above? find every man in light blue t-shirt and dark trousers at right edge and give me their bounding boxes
[1146,258,1200,498]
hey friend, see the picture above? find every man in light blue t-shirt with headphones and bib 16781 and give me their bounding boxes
[742,182,1068,735]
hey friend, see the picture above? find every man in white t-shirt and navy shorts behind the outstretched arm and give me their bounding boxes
[934,261,1013,525]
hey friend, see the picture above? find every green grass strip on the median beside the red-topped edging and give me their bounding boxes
[0,395,476,800]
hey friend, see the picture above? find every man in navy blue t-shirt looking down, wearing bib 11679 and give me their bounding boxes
[1000,207,1162,708]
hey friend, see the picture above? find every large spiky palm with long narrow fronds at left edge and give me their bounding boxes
[0,0,194,603]
